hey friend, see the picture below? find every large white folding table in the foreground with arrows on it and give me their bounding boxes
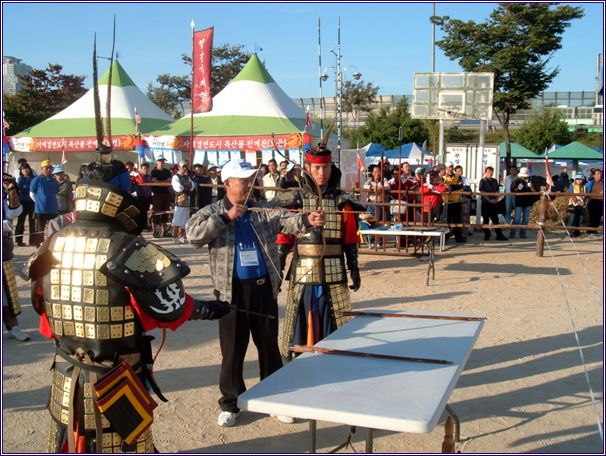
[238,311,484,453]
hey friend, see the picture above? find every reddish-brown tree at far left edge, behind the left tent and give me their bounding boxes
[3,63,86,135]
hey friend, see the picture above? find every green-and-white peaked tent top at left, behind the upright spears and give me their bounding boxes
[12,60,173,152]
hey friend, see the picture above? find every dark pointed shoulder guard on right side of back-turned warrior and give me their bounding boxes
[100,236,190,290]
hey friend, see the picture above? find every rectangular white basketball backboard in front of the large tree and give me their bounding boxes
[411,73,494,120]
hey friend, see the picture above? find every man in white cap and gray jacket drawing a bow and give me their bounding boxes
[186,159,325,426]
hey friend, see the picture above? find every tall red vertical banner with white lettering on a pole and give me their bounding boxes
[192,27,214,112]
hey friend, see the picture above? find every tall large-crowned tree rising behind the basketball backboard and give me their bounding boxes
[431,3,583,169]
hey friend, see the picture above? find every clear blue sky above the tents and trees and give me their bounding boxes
[2,2,604,98]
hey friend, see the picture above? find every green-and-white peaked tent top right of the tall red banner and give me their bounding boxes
[148,54,337,151]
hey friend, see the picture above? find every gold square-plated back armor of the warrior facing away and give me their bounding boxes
[42,224,141,350]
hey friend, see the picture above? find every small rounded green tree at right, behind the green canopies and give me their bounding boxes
[514,108,572,154]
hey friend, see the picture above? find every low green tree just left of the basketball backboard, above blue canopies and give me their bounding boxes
[352,98,429,149]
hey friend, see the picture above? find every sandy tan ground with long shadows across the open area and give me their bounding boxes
[2,228,604,453]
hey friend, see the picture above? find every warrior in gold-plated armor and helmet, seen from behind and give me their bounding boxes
[23,154,229,453]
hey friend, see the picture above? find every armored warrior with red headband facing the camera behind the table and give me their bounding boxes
[271,129,365,359]
